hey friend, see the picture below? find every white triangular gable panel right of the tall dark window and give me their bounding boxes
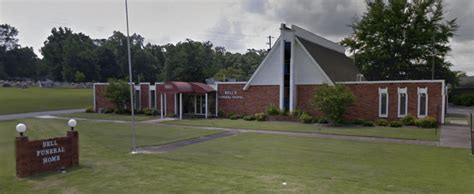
[293,38,331,85]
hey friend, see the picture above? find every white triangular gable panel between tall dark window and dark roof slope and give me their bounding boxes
[295,38,334,85]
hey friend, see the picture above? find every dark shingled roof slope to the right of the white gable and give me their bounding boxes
[297,37,360,82]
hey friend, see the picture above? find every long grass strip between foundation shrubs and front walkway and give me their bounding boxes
[163,119,439,141]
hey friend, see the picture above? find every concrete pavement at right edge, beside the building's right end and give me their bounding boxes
[440,125,471,148]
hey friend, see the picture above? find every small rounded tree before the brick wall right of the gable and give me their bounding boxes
[313,85,355,124]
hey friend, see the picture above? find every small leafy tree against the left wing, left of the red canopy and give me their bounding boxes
[105,79,130,113]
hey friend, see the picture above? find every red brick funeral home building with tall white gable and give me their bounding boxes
[94,24,446,123]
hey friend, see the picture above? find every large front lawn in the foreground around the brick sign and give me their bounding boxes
[0,119,474,193]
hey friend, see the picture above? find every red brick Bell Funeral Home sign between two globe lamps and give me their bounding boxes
[16,131,79,177]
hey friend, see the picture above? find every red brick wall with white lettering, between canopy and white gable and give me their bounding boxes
[218,84,280,114]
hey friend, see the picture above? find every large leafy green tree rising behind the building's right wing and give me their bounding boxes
[341,0,458,83]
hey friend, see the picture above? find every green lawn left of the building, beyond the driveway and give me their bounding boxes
[0,88,92,115]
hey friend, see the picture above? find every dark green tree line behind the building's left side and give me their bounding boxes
[0,24,267,82]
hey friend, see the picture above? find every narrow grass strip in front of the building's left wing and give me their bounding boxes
[58,113,160,121]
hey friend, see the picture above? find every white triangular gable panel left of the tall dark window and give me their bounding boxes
[244,37,283,90]
